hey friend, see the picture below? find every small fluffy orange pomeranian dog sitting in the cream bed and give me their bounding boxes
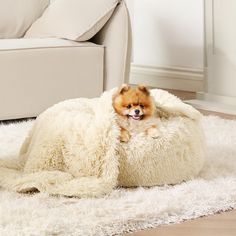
[112,84,160,142]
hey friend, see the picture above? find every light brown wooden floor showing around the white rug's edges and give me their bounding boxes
[125,90,236,236]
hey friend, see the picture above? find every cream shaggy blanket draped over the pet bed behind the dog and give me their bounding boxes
[0,89,201,197]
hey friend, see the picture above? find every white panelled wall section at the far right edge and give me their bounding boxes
[196,0,236,108]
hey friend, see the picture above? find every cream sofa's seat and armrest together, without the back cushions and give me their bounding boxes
[0,1,131,120]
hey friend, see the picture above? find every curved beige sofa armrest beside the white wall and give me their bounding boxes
[91,1,132,90]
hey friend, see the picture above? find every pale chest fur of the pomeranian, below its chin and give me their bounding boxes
[118,117,160,136]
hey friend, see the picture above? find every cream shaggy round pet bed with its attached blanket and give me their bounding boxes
[0,89,204,197]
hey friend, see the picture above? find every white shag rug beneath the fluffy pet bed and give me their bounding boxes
[0,116,236,236]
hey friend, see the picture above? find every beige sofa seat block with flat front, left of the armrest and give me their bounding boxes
[0,39,104,120]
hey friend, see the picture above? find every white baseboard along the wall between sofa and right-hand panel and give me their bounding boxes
[130,64,204,92]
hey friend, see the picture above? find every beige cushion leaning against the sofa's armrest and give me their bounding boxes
[25,0,119,41]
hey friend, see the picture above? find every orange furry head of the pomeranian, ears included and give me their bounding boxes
[113,85,155,120]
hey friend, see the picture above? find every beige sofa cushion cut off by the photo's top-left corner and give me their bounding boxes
[0,0,50,38]
